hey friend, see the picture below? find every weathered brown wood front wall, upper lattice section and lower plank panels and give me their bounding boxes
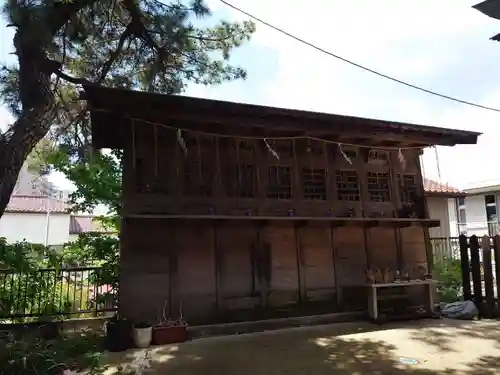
[120,124,434,322]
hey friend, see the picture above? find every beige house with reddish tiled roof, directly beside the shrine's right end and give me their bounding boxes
[424,179,466,238]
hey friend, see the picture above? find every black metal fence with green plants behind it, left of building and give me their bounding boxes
[0,267,118,320]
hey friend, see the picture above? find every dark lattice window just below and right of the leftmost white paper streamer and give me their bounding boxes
[183,161,215,197]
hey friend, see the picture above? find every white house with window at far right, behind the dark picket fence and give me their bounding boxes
[459,181,500,236]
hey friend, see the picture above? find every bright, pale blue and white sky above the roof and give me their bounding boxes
[0,0,500,192]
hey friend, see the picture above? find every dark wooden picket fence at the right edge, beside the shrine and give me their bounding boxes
[459,235,500,318]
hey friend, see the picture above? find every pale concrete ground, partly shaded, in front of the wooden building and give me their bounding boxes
[106,319,500,375]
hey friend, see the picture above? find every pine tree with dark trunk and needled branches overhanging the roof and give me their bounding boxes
[0,0,255,220]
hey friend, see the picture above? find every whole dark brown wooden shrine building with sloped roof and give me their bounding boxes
[84,86,479,324]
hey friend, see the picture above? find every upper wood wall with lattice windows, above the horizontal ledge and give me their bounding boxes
[120,123,424,217]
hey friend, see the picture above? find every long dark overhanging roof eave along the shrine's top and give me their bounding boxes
[82,85,481,148]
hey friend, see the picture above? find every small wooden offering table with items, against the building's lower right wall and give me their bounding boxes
[366,279,437,321]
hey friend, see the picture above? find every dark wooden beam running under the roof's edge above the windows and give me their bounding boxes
[93,106,477,147]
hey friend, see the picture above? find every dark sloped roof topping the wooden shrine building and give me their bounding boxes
[82,85,480,148]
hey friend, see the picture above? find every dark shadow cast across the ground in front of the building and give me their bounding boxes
[108,320,500,375]
